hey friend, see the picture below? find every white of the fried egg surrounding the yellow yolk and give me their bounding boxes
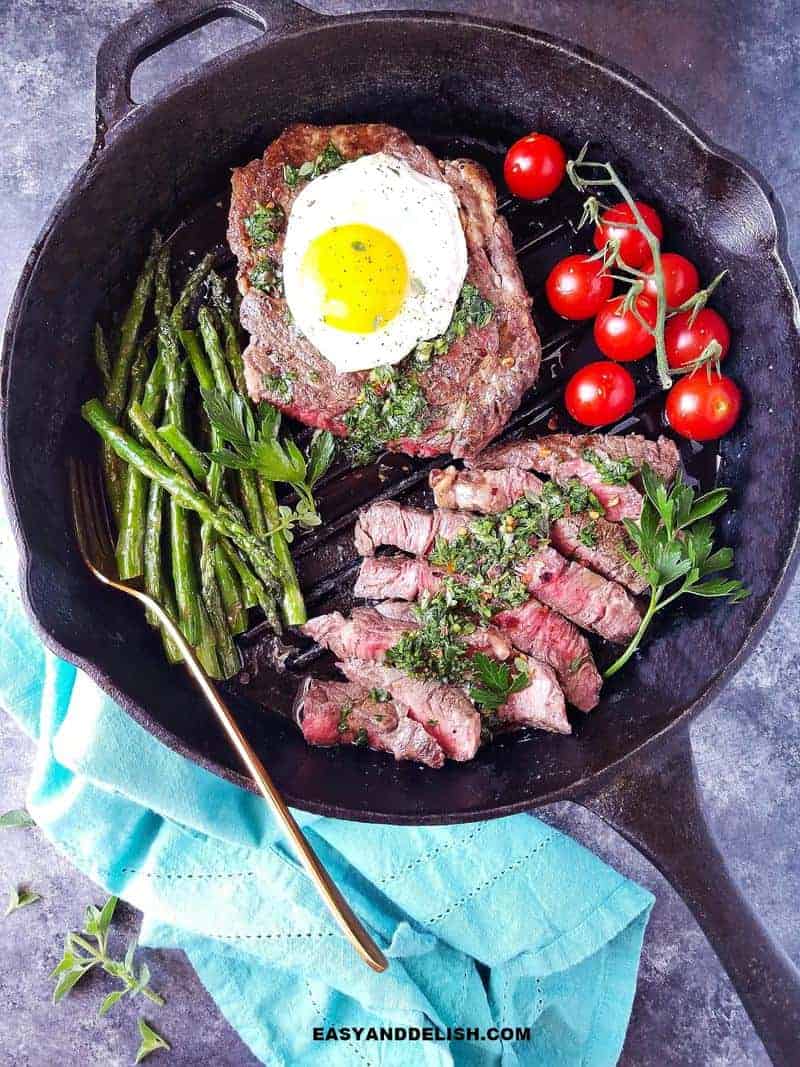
[283,153,467,372]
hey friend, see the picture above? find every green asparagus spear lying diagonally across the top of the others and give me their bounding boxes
[81,398,279,630]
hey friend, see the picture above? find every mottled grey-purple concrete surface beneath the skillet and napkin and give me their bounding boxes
[0,0,800,1067]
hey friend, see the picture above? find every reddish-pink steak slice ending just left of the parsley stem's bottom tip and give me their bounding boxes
[493,599,603,712]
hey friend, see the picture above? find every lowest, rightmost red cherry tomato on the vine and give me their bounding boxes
[667,367,741,441]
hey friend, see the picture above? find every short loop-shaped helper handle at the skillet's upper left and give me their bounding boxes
[95,0,325,137]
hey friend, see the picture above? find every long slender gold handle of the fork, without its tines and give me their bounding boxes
[140,587,388,973]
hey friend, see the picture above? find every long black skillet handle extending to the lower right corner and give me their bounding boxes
[576,727,800,1067]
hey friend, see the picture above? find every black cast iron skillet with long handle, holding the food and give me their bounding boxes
[2,0,800,1064]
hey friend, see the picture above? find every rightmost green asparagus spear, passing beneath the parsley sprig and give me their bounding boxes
[206,296,308,626]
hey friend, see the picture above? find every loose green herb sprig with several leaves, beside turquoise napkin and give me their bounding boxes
[50,896,164,1015]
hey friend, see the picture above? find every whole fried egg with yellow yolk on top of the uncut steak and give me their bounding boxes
[283,153,467,372]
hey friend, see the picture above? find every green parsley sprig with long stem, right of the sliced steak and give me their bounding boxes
[605,465,749,678]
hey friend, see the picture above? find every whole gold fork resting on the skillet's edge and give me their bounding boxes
[69,460,388,973]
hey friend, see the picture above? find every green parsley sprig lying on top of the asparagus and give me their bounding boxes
[203,389,336,541]
